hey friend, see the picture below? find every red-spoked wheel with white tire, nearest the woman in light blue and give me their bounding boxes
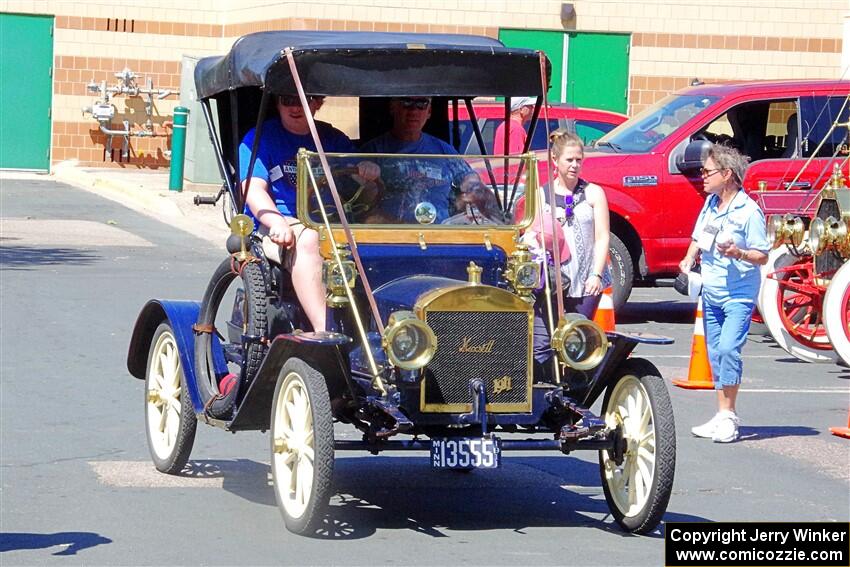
[759,249,836,362]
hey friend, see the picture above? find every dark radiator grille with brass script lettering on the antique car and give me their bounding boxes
[422,311,531,412]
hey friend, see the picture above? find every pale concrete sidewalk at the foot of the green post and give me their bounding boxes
[45,161,230,248]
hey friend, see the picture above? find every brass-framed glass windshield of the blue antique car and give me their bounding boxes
[298,151,537,228]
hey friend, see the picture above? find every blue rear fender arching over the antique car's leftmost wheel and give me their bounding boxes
[127,299,203,410]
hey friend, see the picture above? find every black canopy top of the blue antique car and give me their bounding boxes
[195,31,550,99]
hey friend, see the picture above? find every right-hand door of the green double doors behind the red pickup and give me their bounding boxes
[564,32,629,114]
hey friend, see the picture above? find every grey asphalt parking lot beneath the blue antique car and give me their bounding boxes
[0,173,850,566]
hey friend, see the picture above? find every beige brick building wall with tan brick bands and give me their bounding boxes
[0,0,850,167]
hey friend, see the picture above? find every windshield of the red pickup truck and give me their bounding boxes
[595,95,718,153]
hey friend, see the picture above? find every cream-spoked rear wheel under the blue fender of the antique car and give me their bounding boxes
[145,321,198,474]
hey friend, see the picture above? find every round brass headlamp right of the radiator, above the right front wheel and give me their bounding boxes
[552,313,608,370]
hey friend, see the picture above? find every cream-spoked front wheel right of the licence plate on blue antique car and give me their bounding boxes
[599,358,676,534]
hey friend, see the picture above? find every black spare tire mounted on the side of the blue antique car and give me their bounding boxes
[195,258,268,419]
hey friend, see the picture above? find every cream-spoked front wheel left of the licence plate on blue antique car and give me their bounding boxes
[270,358,334,535]
